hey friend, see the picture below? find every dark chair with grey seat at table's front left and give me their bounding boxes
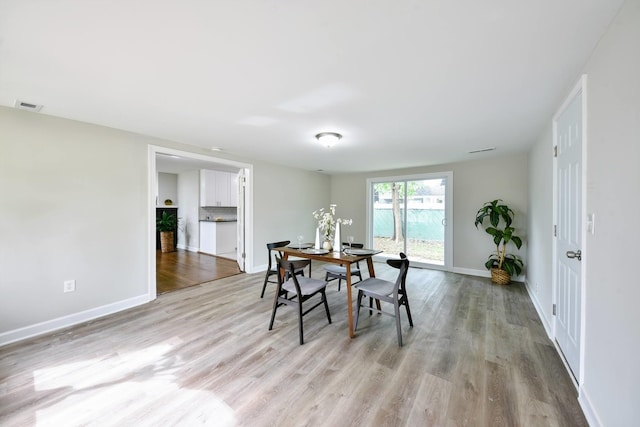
[269,257,331,345]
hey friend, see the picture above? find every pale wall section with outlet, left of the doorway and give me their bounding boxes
[0,108,149,334]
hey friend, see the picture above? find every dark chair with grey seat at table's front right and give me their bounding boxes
[354,253,413,347]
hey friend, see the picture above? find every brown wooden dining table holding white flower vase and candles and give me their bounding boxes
[273,246,383,338]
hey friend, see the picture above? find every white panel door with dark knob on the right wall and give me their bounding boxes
[555,84,583,380]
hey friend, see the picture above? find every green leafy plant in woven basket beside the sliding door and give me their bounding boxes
[475,199,524,285]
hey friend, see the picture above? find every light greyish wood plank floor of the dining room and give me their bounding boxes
[0,263,587,426]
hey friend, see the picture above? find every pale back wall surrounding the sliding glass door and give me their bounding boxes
[331,153,528,275]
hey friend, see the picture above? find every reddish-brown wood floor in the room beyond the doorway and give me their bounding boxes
[156,249,241,294]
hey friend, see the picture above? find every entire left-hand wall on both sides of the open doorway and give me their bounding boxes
[0,107,330,345]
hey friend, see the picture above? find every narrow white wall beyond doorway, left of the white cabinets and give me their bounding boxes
[178,170,200,252]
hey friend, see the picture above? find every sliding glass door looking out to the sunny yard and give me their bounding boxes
[367,172,453,270]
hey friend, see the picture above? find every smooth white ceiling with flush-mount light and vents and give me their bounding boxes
[0,0,622,173]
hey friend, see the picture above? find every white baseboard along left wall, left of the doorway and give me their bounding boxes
[0,294,151,346]
